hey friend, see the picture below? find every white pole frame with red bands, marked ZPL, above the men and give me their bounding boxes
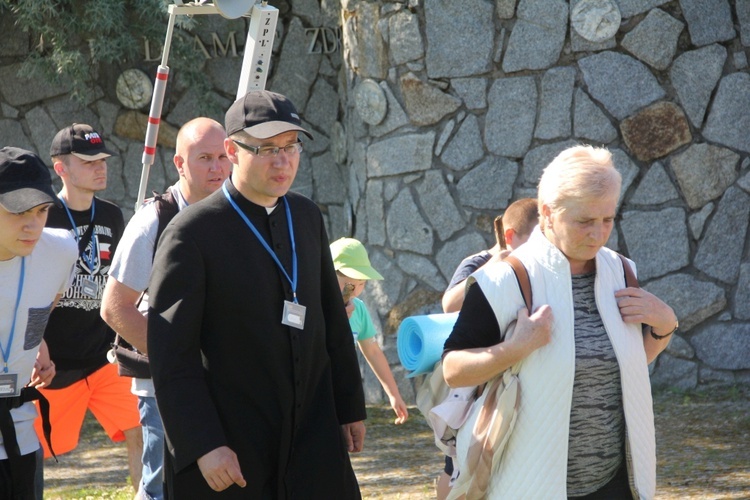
[135,0,279,211]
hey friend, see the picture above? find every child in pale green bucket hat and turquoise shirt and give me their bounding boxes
[331,238,409,424]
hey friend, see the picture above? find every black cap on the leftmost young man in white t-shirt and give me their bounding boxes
[0,147,60,214]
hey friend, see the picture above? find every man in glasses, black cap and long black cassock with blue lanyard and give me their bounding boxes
[148,91,365,500]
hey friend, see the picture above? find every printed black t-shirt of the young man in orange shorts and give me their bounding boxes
[44,198,125,376]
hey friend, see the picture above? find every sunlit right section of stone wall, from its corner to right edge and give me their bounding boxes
[339,0,750,400]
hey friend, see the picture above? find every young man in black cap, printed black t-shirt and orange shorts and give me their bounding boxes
[36,123,143,488]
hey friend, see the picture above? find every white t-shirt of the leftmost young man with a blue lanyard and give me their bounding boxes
[0,228,78,460]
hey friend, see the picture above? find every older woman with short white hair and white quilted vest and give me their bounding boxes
[443,146,677,500]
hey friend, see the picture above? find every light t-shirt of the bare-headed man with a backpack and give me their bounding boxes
[109,183,187,396]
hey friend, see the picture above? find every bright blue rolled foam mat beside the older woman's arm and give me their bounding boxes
[396,313,458,378]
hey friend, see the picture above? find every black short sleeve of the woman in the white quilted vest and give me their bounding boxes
[443,283,501,355]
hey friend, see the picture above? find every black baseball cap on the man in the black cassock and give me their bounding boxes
[224,90,313,139]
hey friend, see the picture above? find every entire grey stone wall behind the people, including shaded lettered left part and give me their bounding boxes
[0,0,750,401]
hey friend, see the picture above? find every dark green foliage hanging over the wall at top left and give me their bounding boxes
[0,0,210,101]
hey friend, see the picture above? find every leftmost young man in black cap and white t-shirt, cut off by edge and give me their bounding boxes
[0,147,77,500]
